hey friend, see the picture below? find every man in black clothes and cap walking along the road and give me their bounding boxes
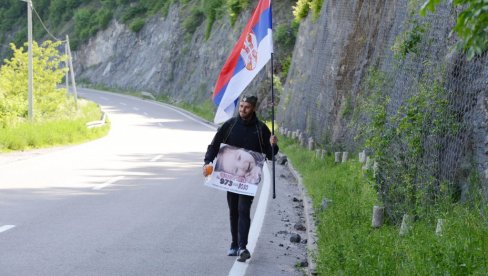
[203,96,279,262]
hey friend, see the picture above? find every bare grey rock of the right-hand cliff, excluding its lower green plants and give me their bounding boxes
[277,0,488,196]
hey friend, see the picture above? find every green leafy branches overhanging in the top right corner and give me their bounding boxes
[420,0,488,60]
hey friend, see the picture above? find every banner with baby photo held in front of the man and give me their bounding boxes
[205,144,265,196]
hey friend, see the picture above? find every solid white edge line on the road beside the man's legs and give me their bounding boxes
[229,162,271,276]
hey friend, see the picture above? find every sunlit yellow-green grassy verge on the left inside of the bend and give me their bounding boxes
[0,100,110,152]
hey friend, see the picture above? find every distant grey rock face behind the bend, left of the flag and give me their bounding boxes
[73,0,293,103]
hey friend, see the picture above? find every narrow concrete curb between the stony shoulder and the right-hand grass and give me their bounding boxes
[286,157,317,275]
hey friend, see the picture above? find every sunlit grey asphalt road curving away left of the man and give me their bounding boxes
[0,89,250,275]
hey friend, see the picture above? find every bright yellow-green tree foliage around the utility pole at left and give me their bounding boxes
[0,41,70,128]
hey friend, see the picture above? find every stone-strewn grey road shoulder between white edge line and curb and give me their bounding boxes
[246,156,313,275]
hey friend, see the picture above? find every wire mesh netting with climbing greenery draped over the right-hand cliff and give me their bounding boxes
[278,0,488,222]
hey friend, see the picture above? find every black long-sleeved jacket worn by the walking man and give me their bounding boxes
[204,113,279,164]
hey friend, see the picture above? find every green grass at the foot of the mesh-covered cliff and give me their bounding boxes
[280,137,488,275]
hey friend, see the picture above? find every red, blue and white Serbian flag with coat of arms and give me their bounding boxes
[212,0,273,124]
